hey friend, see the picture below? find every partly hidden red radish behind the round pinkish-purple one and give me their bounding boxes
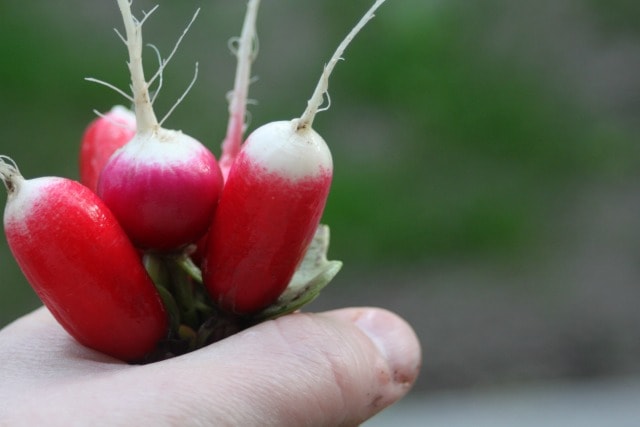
[80,105,136,192]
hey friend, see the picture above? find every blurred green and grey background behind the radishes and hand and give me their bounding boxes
[0,0,640,391]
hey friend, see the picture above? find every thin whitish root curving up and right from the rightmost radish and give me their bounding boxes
[296,0,385,132]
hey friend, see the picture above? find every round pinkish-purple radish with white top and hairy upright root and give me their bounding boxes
[98,0,222,251]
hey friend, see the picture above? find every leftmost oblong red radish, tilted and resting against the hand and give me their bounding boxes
[0,156,168,361]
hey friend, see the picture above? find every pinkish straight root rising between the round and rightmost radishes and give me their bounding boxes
[218,0,260,180]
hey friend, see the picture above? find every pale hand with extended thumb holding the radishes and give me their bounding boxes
[0,308,421,427]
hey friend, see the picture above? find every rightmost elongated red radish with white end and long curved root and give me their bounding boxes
[203,0,384,313]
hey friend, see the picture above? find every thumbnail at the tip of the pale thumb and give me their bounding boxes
[354,309,422,384]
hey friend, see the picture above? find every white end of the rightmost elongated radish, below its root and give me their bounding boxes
[243,120,333,180]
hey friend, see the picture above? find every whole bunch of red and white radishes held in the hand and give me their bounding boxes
[0,0,384,362]
